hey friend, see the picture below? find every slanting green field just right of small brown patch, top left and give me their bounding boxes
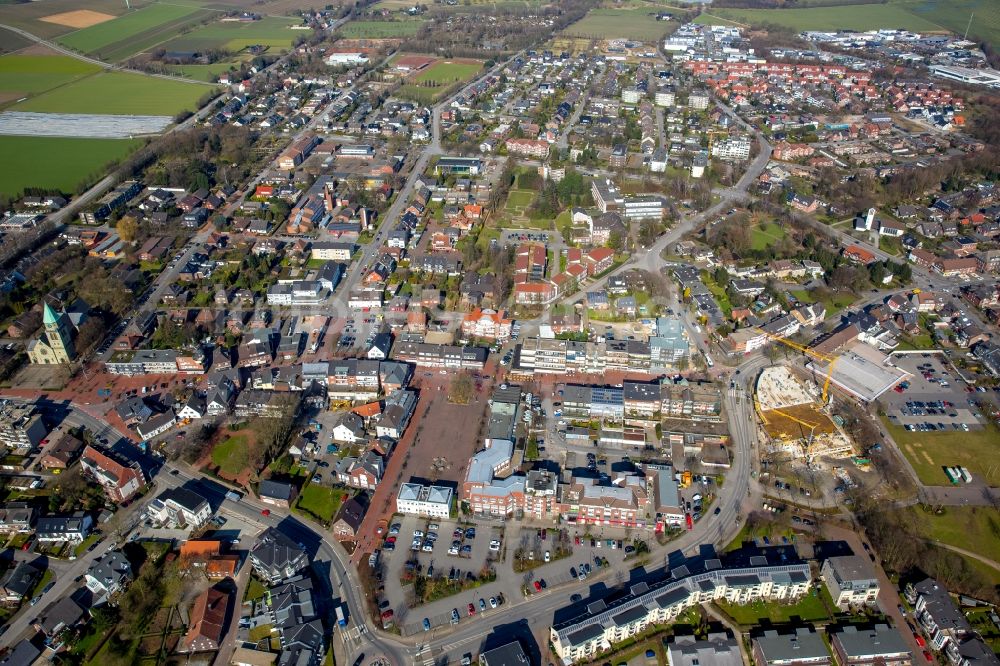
[59,4,207,60]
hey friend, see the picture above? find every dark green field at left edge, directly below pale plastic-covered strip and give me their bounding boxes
[0,136,142,196]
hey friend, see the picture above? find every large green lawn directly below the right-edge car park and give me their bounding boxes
[882,417,1000,486]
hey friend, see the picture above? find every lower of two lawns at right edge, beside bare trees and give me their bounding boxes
[907,506,1000,564]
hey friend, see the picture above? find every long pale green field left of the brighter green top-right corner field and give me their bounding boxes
[696,3,944,32]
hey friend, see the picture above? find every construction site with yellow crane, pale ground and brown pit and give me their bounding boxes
[754,365,854,461]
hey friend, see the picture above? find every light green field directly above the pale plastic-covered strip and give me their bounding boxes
[13,72,209,116]
